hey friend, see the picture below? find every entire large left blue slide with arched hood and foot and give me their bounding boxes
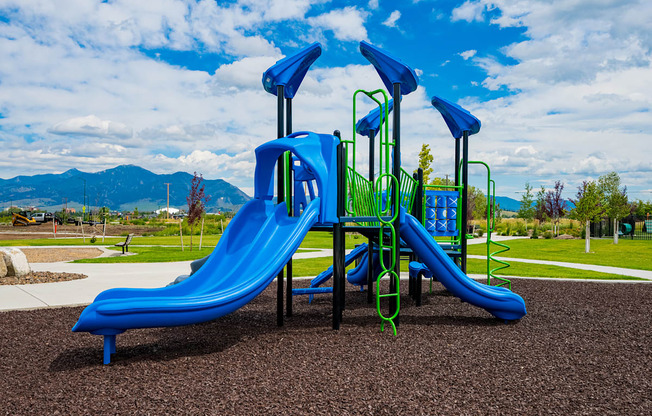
[72,132,339,364]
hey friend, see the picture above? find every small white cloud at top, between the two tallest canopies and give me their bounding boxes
[307,6,368,41]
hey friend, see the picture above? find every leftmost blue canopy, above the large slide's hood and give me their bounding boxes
[263,42,321,98]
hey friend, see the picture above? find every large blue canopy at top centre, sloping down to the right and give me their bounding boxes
[360,40,419,95]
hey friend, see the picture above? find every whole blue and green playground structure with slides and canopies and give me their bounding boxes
[73,41,526,364]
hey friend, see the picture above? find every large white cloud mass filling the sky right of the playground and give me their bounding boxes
[451,0,652,194]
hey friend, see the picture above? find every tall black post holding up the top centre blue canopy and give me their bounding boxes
[390,82,401,326]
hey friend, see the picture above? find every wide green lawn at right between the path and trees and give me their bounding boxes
[469,239,652,270]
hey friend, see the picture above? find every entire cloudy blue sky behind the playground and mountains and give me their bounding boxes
[0,0,652,200]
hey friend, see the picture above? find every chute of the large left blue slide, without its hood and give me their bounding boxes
[72,198,319,335]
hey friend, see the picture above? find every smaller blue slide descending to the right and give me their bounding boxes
[401,212,527,321]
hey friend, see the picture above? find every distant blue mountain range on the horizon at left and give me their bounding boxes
[0,165,251,212]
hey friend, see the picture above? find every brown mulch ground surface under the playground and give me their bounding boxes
[0,280,652,415]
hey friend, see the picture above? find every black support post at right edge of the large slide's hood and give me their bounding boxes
[333,130,346,329]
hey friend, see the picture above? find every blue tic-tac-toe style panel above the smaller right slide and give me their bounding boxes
[425,190,459,237]
